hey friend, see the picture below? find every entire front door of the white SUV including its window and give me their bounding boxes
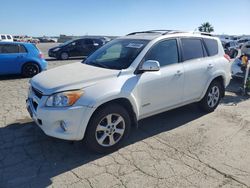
[139,39,184,116]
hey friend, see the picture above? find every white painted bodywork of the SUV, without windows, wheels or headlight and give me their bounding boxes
[27,33,231,140]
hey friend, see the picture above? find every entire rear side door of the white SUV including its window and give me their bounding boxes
[180,38,214,102]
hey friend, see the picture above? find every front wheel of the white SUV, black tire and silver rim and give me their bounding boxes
[85,104,131,153]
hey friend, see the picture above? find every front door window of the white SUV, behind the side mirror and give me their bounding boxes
[145,40,178,67]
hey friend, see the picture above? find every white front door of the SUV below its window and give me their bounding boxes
[139,63,184,116]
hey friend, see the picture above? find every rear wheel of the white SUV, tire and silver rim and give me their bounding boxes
[199,81,223,113]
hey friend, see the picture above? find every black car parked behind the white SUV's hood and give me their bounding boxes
[48,38,109,60]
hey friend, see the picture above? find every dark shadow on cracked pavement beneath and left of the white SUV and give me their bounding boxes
[0,105,204,187]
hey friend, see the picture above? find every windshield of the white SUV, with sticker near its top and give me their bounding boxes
[82,39,149,70]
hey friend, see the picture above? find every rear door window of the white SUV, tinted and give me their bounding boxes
[181,38,203,61]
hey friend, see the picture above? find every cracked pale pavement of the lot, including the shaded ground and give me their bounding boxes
[0,44,250,188]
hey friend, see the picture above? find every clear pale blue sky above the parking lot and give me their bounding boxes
[0,0,250,36]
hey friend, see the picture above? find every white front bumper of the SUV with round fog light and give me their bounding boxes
[26,88,94,140]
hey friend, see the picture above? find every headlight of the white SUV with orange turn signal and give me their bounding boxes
[46,90,83,107]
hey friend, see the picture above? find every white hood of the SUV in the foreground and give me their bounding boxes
[30,62,120,95]
